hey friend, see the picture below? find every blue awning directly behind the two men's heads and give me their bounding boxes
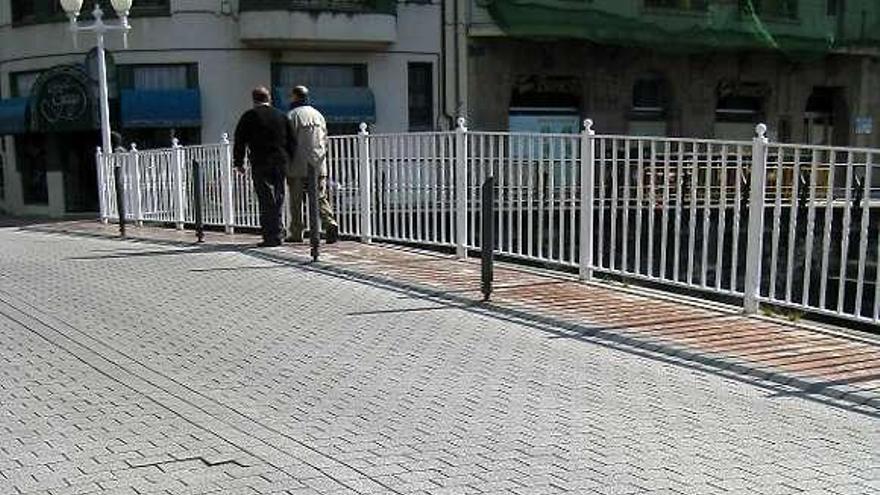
[273,86,376,124]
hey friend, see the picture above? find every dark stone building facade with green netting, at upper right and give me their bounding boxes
[445,0,880,146]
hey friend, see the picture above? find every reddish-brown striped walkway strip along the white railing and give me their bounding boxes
[31,221,880,409]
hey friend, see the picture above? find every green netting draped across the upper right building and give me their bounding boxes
[485,0,880,56]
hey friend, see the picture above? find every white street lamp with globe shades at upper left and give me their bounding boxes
[61,0,132,153]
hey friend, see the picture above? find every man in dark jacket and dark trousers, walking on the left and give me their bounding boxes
[233,86,293,247]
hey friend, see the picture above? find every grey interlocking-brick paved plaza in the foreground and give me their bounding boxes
[0,228,880,495]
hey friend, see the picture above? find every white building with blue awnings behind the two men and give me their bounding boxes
[0,0,440,216]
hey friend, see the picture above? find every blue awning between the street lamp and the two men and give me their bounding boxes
[120,89,202,128]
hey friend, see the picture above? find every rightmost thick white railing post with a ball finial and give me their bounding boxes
[743,124,769,314]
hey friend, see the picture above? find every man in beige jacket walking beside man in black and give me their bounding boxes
[287,86,339,244]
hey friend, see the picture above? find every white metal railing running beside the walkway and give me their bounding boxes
[98,121,880,324]
